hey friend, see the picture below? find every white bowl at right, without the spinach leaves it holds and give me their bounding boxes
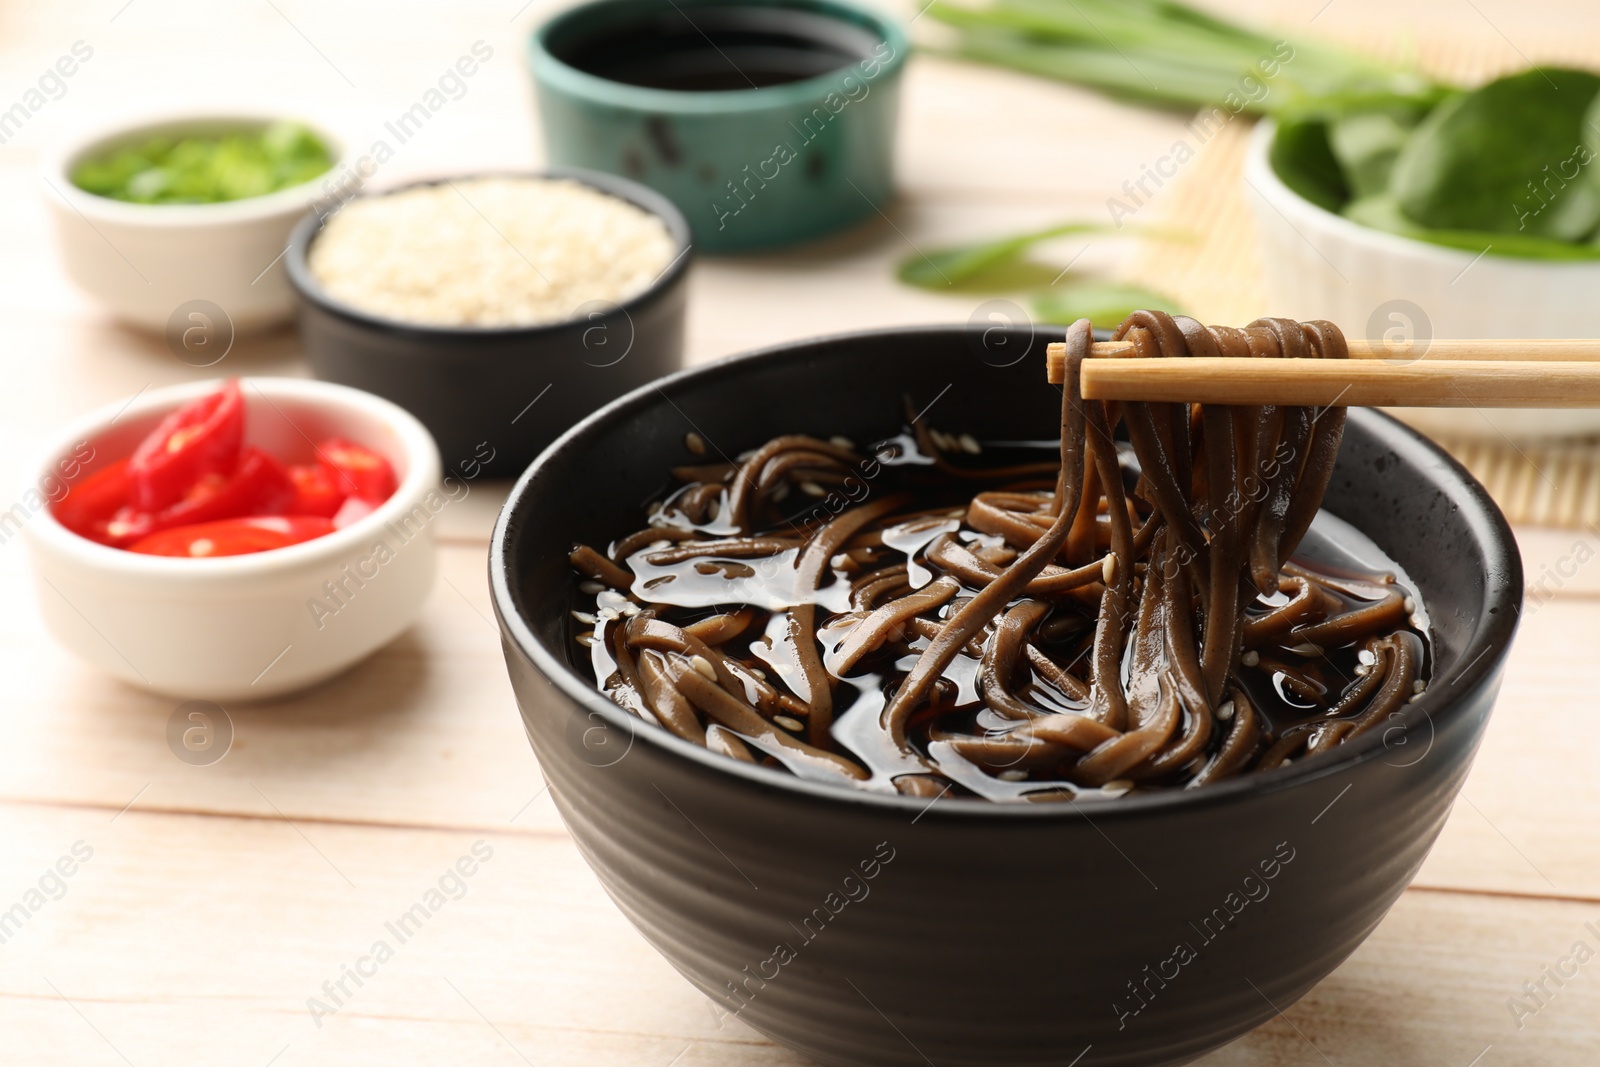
[1245,122,1600,438]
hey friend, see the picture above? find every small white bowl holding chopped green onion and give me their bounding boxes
[38,109,354,331]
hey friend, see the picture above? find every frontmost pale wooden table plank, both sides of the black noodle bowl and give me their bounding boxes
[0,805,1600,1067]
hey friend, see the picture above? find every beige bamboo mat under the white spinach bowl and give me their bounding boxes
[1130,20,1600,528]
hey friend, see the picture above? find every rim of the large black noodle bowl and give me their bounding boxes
[488,323,1522,822]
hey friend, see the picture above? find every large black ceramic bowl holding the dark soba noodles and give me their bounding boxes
[490,328,1522,1067]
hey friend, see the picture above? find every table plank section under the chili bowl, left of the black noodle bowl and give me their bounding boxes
[0,545,557,830]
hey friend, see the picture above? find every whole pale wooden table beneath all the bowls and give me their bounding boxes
[0,0,1600,1067]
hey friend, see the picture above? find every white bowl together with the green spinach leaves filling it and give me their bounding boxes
[1245,69,1600,437]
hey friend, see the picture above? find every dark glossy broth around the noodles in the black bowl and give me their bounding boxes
[568,415,1427,800]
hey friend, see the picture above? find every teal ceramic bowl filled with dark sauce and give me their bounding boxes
[528,0,910,253]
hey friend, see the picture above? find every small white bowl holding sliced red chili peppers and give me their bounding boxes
[24,378,448,701]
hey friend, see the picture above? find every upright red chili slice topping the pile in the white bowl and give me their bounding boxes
[128,378,245,514]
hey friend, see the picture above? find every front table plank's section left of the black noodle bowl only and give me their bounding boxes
[0,801,797,1067]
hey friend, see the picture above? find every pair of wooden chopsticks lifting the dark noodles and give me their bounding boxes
[1048,341,1600,408]
